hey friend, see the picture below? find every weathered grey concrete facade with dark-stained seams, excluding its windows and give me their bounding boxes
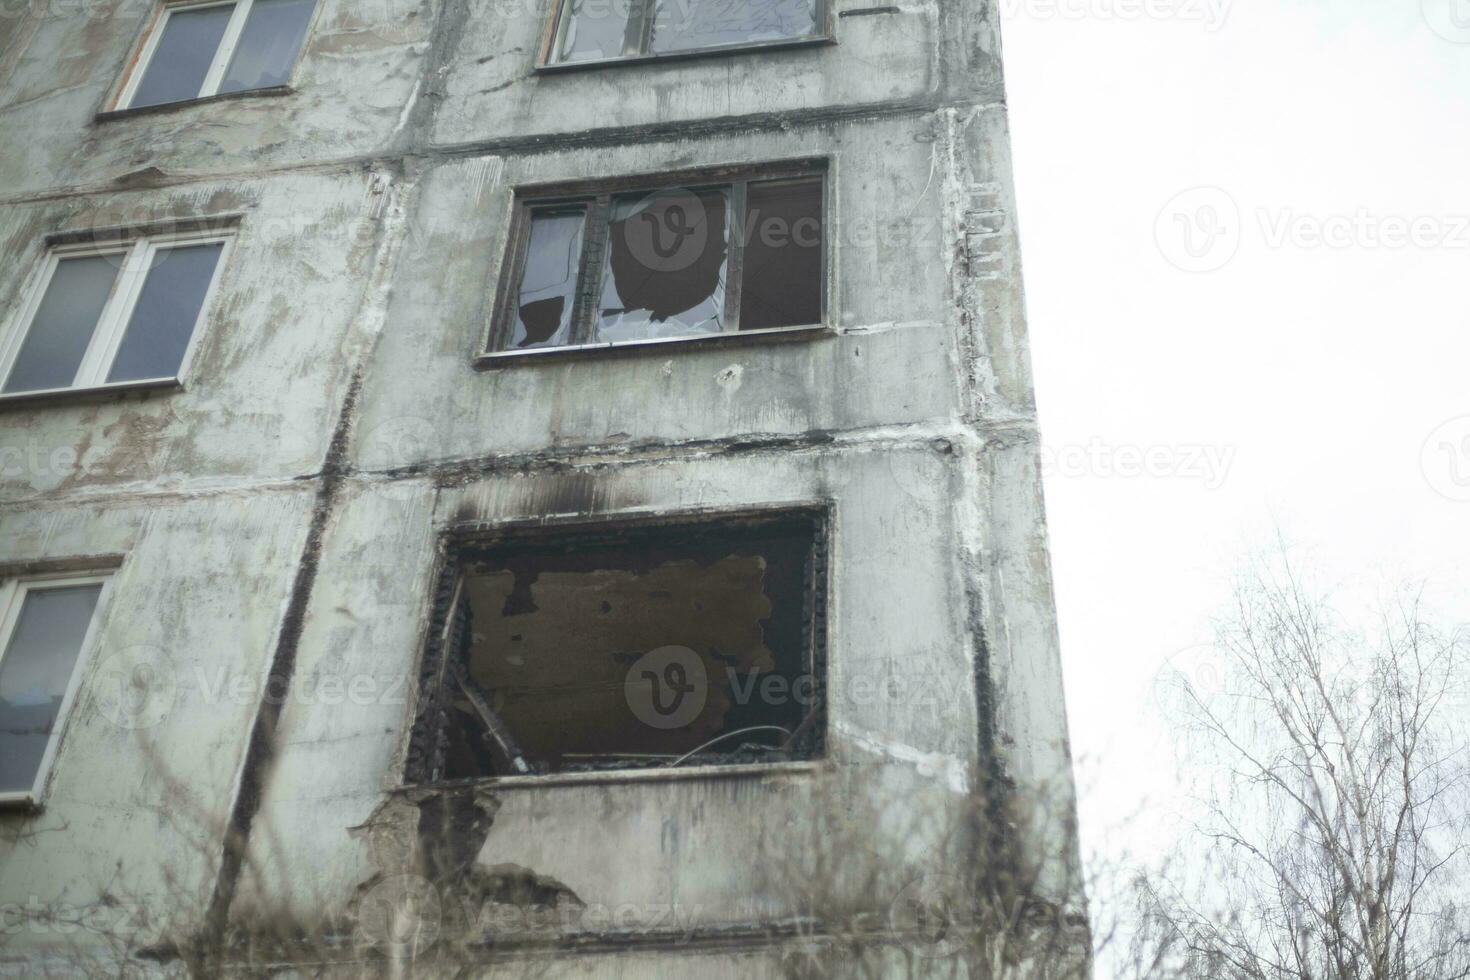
[0,0,1085,977]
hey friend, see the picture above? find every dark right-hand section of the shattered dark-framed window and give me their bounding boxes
[739,179,823,331]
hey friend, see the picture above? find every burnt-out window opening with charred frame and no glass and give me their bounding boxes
[407,510,825,783]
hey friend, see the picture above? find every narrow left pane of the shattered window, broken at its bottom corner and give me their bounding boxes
[510,207,587,348]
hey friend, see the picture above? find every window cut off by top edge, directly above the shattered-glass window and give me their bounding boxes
[547,0,825,65]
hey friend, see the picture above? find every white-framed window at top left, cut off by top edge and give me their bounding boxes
[118,0,316,107]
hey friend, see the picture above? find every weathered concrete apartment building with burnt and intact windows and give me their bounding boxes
[0,0,1086,977]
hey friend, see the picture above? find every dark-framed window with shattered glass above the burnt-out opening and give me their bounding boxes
[491,163,825,351]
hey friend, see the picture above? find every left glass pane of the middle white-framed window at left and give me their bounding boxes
[4,253,122,391]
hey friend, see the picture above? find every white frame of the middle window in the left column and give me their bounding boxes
[0,231,235,401]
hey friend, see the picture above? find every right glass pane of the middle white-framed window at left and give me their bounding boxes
[107,241,225,382]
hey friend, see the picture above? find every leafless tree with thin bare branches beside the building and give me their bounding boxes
[1136,547,1470,980]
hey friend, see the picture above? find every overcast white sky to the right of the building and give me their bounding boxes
[1000,0,1470,881]
